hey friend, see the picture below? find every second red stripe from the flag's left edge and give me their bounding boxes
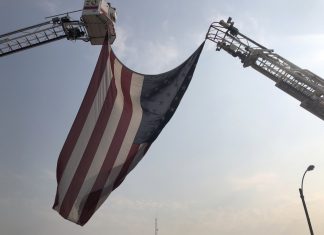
[60,52,117,218]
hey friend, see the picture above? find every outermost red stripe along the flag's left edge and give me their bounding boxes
[56,43,109,183]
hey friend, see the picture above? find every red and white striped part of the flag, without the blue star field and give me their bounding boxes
[53,45,149,225]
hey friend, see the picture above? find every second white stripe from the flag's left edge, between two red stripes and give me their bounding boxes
[69,57,124,220]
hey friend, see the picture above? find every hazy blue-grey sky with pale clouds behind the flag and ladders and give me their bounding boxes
[0,0,324,235]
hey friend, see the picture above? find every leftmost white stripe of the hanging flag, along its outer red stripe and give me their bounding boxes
[55,51,111,211]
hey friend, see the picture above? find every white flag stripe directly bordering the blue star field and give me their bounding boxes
[96,73,144,209]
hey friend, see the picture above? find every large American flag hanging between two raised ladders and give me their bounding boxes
[53,40,204,225]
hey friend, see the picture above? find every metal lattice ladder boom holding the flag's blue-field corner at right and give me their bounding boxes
[206,18,324,120]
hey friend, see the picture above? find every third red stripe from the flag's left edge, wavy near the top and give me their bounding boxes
[78,67,133,225]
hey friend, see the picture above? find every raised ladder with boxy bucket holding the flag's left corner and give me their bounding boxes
[0,0,116,57]
